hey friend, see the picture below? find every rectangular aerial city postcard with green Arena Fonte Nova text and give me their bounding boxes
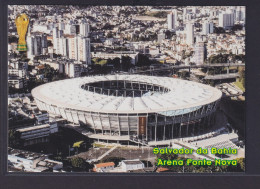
[6,5,246,175]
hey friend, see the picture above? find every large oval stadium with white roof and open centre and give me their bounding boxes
[32,75,222,141]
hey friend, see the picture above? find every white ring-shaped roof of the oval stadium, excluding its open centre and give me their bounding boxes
[32,75,222,115]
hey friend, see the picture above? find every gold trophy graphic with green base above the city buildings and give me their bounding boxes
[15,13,29,51]
